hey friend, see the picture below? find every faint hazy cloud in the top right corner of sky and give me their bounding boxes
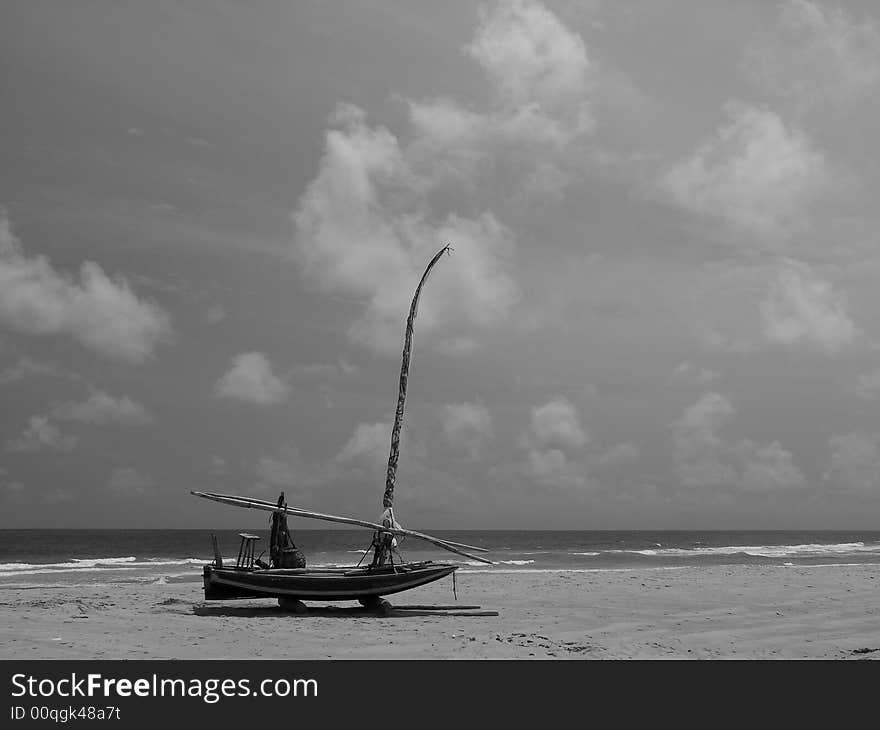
[744,0,880,109]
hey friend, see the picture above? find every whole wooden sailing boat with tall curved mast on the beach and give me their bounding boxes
[192,246,492,610]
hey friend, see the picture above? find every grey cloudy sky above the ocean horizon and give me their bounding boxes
[0,0,880,529]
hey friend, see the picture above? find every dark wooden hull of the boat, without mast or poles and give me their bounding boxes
[204,562,458,601]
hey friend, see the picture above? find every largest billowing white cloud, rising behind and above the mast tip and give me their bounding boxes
[294,0,616,353]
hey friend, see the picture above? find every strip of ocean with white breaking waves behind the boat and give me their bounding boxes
[0,530,880,590]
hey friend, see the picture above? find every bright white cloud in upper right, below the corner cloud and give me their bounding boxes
[662,104,831,239]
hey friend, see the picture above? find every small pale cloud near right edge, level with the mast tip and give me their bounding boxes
[761,259,859,353]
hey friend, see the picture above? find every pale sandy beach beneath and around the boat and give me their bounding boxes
[0,565,880,659]
